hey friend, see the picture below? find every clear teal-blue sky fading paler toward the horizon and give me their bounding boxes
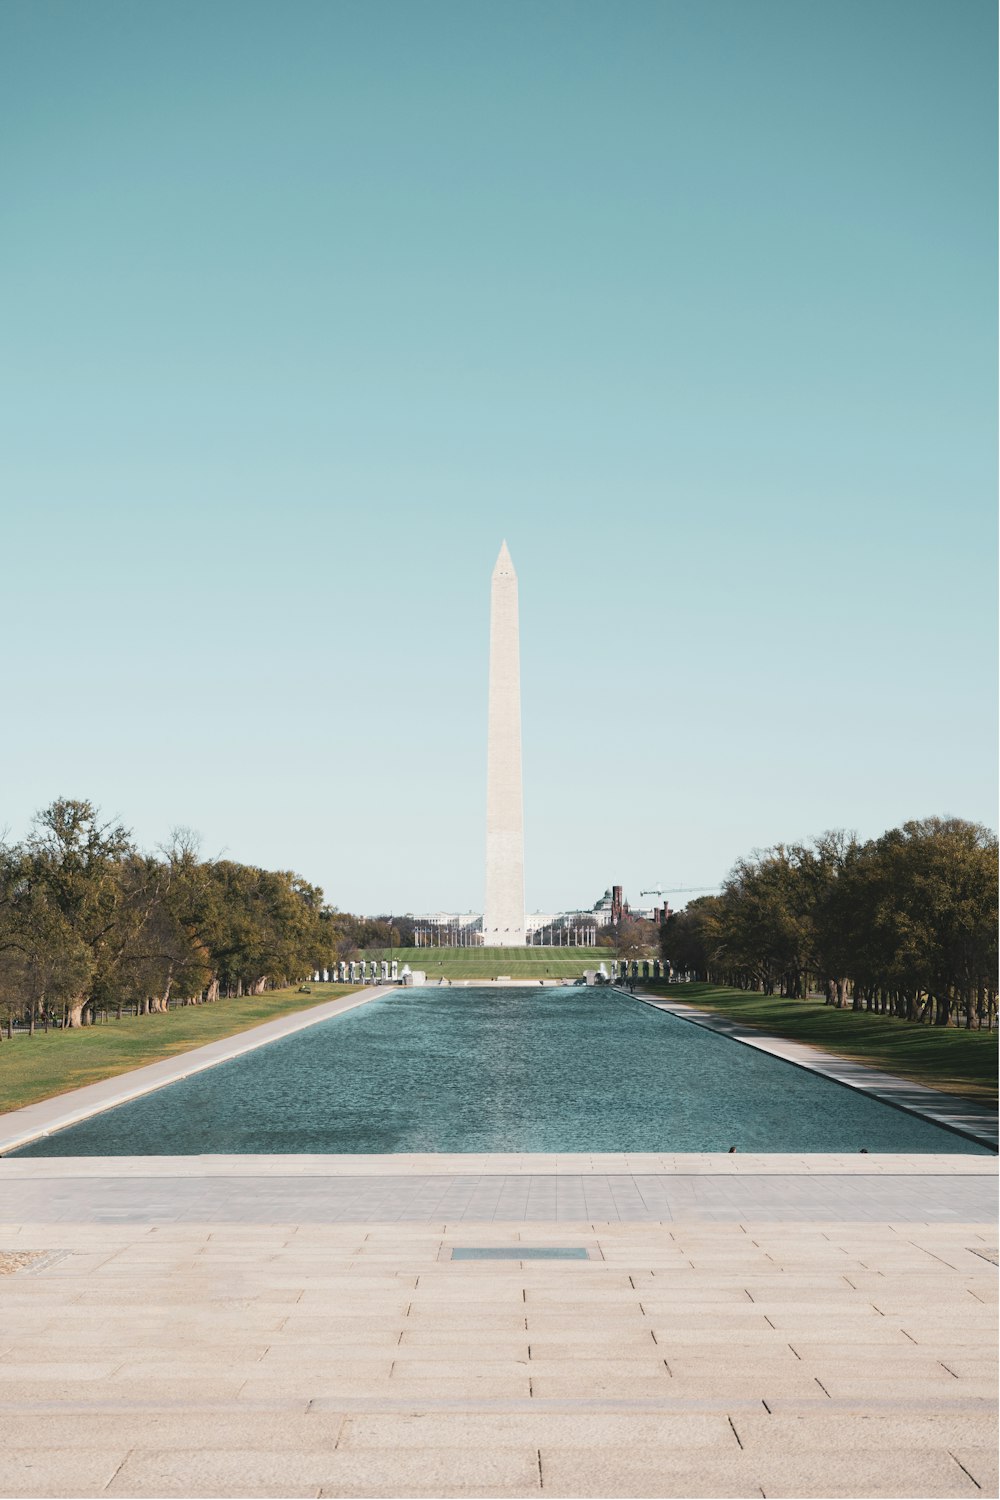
[0,0,996,911]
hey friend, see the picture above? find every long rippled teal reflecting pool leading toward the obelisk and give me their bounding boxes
[9,987,988,1157]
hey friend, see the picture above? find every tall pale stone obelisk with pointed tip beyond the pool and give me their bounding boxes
[483,542,525,948]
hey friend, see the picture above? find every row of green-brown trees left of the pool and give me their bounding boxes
[0,798,341,1035]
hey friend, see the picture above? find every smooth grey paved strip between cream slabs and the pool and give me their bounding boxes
[0,1157,997,1224]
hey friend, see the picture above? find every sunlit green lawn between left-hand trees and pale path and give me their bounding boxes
[0,984,351,1113]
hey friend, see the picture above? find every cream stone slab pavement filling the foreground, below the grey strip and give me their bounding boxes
[0,1157,997,1497]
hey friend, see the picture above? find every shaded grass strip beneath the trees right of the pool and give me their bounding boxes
[642,980,997,1103]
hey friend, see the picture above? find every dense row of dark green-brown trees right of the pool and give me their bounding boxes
[661,818,997,1029]
